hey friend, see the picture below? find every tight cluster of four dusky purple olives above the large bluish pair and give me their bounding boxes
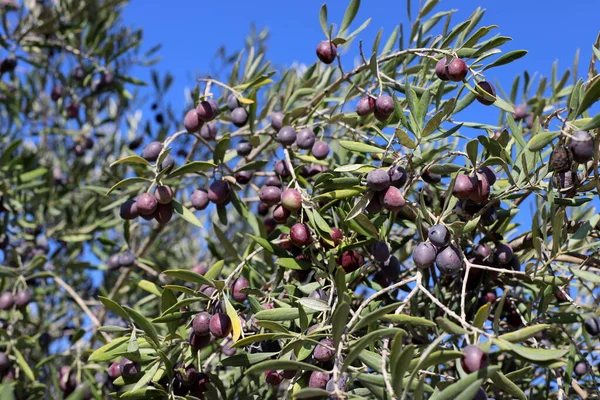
[366,166,408,214]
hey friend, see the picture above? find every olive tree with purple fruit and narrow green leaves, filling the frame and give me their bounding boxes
[0,0,600,399]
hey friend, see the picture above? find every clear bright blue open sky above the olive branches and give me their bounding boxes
[125,0,600,114]
